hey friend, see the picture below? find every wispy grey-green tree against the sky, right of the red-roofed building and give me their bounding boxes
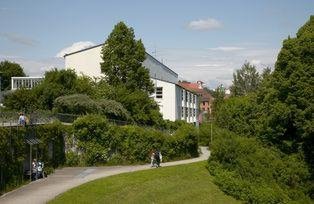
[231,62,261,96]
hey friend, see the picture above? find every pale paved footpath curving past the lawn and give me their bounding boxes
[0,147,210,204]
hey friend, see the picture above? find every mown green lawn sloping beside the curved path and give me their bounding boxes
[49,161,239,204]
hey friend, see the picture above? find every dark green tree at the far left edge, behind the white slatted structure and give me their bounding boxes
[0,61,25,91]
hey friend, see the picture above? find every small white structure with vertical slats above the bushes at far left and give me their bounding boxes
[11,77,44,90]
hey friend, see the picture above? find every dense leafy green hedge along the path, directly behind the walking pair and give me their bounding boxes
[69,115,198,165]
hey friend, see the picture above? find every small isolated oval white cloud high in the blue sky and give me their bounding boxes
[188,18,222,31]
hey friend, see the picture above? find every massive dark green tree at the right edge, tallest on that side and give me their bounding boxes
[258,16,314,164]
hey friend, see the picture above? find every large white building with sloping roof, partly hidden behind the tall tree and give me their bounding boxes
[64,44,199,124]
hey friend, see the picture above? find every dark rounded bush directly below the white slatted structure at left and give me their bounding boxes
[4,88,38,112]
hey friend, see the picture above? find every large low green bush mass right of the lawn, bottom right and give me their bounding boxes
[208,128,310,203]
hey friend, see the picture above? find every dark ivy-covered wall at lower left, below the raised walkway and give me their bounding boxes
[0,122,68,194]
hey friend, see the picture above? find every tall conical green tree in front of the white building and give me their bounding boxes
[101,22,154,93]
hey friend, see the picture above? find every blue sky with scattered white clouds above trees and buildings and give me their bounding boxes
[0,0,314,88]
